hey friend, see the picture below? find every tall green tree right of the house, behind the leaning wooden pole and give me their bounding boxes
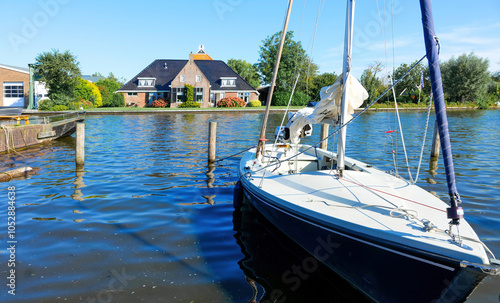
[257,31,318,92]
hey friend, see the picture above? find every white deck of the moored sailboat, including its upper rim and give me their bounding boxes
[240,145,489,264]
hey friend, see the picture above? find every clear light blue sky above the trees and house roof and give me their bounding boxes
[0,0,500,80]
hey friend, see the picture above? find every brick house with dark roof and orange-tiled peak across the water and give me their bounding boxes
[117,45,259,107]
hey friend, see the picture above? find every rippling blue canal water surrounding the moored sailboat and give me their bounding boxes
[0,111,500,303]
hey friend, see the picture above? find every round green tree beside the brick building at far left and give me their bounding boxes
[35,50,81,99]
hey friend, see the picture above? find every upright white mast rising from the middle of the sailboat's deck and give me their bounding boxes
[337,0,355,177]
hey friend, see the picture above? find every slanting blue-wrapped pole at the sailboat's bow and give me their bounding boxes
[420,0,463,225]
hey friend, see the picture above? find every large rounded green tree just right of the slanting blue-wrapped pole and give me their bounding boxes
[441,52,491,103]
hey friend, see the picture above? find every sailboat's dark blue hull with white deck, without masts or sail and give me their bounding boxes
[239,146,496,302]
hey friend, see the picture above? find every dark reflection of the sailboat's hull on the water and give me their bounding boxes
[233,198,370,303]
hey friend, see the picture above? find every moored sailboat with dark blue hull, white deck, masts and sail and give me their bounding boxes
[235,0,500,302]
